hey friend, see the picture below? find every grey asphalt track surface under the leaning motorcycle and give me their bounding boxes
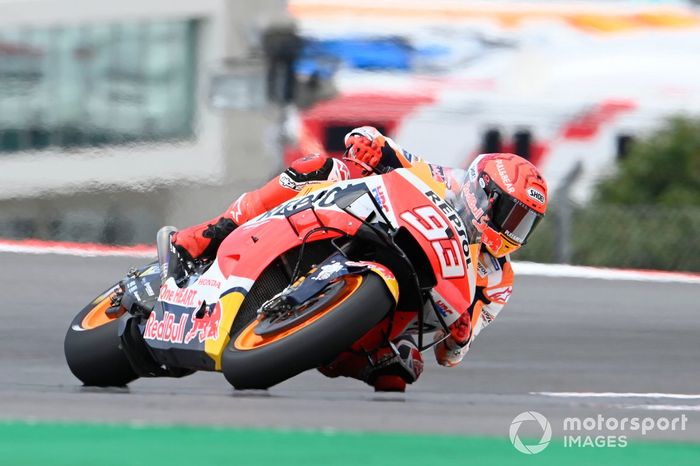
[0,253,700,442]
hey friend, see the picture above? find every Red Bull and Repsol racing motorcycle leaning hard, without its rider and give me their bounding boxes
[64,162,487,389]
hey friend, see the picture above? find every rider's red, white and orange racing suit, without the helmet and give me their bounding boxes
[173,126,513,391]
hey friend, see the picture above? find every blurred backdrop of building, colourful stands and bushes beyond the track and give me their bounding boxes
[0,0,700,272]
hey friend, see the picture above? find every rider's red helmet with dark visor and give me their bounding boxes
[461,154,547,257]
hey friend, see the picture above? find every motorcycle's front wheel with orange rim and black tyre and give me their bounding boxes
[221,273,395,389]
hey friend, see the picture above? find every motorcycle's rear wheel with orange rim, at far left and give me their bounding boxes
[63,287,138,387]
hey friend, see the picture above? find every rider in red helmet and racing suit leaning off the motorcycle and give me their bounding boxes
[173,126,547,391]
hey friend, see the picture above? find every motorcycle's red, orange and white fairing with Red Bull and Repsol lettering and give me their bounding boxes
[141,160,478,370]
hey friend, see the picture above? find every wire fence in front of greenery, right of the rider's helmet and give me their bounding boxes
[513,202,700,272]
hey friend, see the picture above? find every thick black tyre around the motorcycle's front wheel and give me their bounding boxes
[221,273,395,389]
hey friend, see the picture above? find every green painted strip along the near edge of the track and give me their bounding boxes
[0,421,700,466]
